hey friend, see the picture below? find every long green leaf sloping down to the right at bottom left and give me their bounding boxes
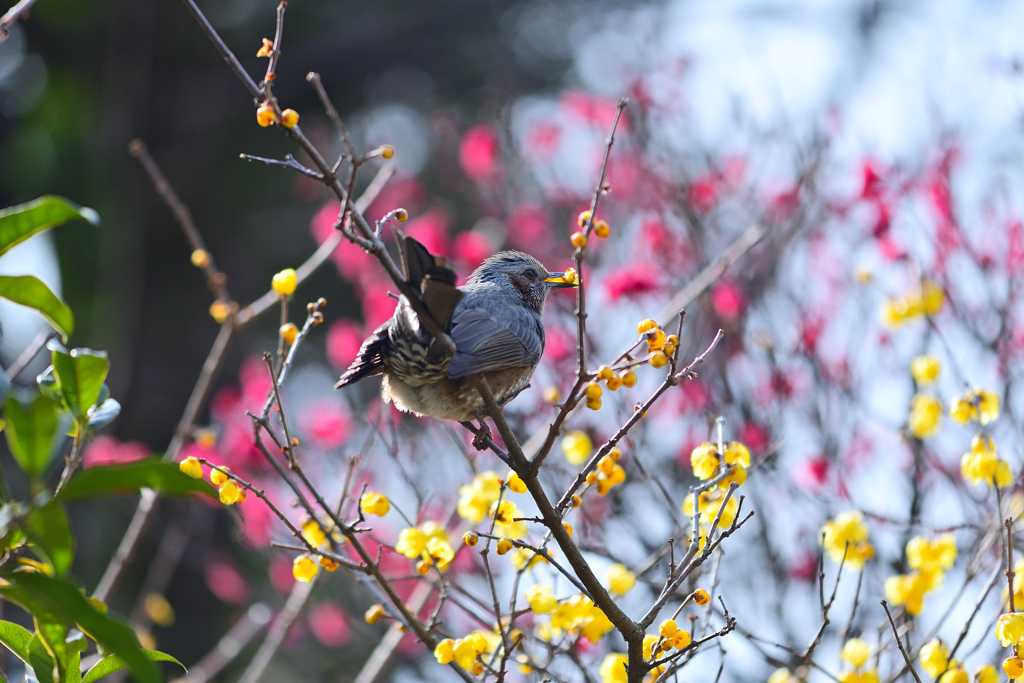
[0,572,160,683]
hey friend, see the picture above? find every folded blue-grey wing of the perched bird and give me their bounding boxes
[447,308,544,379]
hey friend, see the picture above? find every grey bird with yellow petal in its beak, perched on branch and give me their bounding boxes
[334,230,575,422]
